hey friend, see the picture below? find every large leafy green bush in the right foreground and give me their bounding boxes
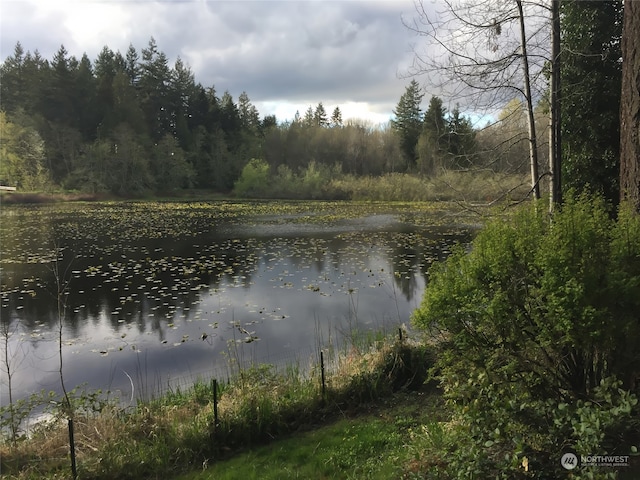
[413,193,640,479]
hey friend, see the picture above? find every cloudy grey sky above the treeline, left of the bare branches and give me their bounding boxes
[0,0,438,125]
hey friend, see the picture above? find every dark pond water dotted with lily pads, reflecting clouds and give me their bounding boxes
[0,202,474,405]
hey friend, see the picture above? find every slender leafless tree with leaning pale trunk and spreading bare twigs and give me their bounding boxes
[406,0,549,197]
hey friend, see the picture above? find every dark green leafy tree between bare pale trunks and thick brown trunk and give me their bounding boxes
[561,0,622,202]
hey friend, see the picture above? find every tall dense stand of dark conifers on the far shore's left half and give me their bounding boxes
[0,38,276,194]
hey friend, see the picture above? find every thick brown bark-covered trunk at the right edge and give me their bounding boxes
[620,0,640,212]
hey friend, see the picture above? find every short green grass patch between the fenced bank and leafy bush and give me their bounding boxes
[178,392,446,480]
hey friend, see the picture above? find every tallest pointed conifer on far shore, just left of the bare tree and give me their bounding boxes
[391,80,424,168]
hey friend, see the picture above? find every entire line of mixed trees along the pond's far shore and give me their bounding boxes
[0,38,536,196]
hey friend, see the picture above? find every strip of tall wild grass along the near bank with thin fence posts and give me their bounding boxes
[0,332,430,479]
